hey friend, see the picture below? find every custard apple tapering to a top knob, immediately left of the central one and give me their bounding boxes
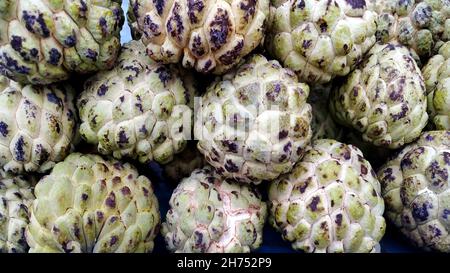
[77,41,194,163]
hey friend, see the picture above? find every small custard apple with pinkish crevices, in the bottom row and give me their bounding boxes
[161,167,267,253]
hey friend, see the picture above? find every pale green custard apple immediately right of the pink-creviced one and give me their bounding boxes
[269,139,386,252]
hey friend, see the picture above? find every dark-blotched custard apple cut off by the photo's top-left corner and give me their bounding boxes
[0,0,124,85]
